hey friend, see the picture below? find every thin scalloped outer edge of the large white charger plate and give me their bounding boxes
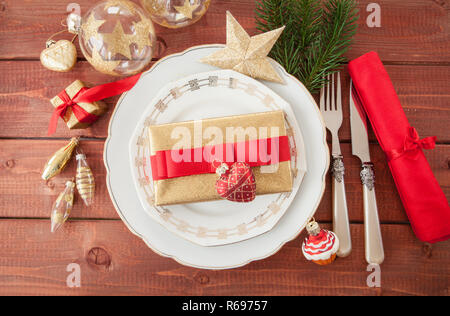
[103,44,330,270]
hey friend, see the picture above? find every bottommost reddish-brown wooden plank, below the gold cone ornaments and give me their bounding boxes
[0,220,450,295]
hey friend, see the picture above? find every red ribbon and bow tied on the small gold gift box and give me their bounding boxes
[48,74,141,135]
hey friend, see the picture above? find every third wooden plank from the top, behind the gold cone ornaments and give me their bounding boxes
[0,140,450,223]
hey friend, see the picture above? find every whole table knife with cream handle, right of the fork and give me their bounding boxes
[350,81,384,264]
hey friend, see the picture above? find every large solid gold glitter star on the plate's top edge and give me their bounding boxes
[201,12,284,83]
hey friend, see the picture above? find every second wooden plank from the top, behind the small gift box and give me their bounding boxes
[0,61,450,143]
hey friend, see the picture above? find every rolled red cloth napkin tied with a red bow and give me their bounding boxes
[349,52,450,243]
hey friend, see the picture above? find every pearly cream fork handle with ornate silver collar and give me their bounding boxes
[331,156,352,258]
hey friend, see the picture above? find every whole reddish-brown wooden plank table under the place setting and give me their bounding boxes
[0,0,450,295]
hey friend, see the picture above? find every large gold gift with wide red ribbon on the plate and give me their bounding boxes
[149,111,292,205]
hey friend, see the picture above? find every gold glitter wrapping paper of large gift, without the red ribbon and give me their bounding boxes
[149,111,292,205]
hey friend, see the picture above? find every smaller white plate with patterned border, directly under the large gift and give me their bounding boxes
[129,70,307,246]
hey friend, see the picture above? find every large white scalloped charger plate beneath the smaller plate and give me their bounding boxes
[104,45,329,269]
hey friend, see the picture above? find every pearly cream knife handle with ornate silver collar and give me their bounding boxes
[361,163,384,265]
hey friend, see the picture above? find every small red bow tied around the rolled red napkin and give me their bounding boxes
[386,126,436,161]
